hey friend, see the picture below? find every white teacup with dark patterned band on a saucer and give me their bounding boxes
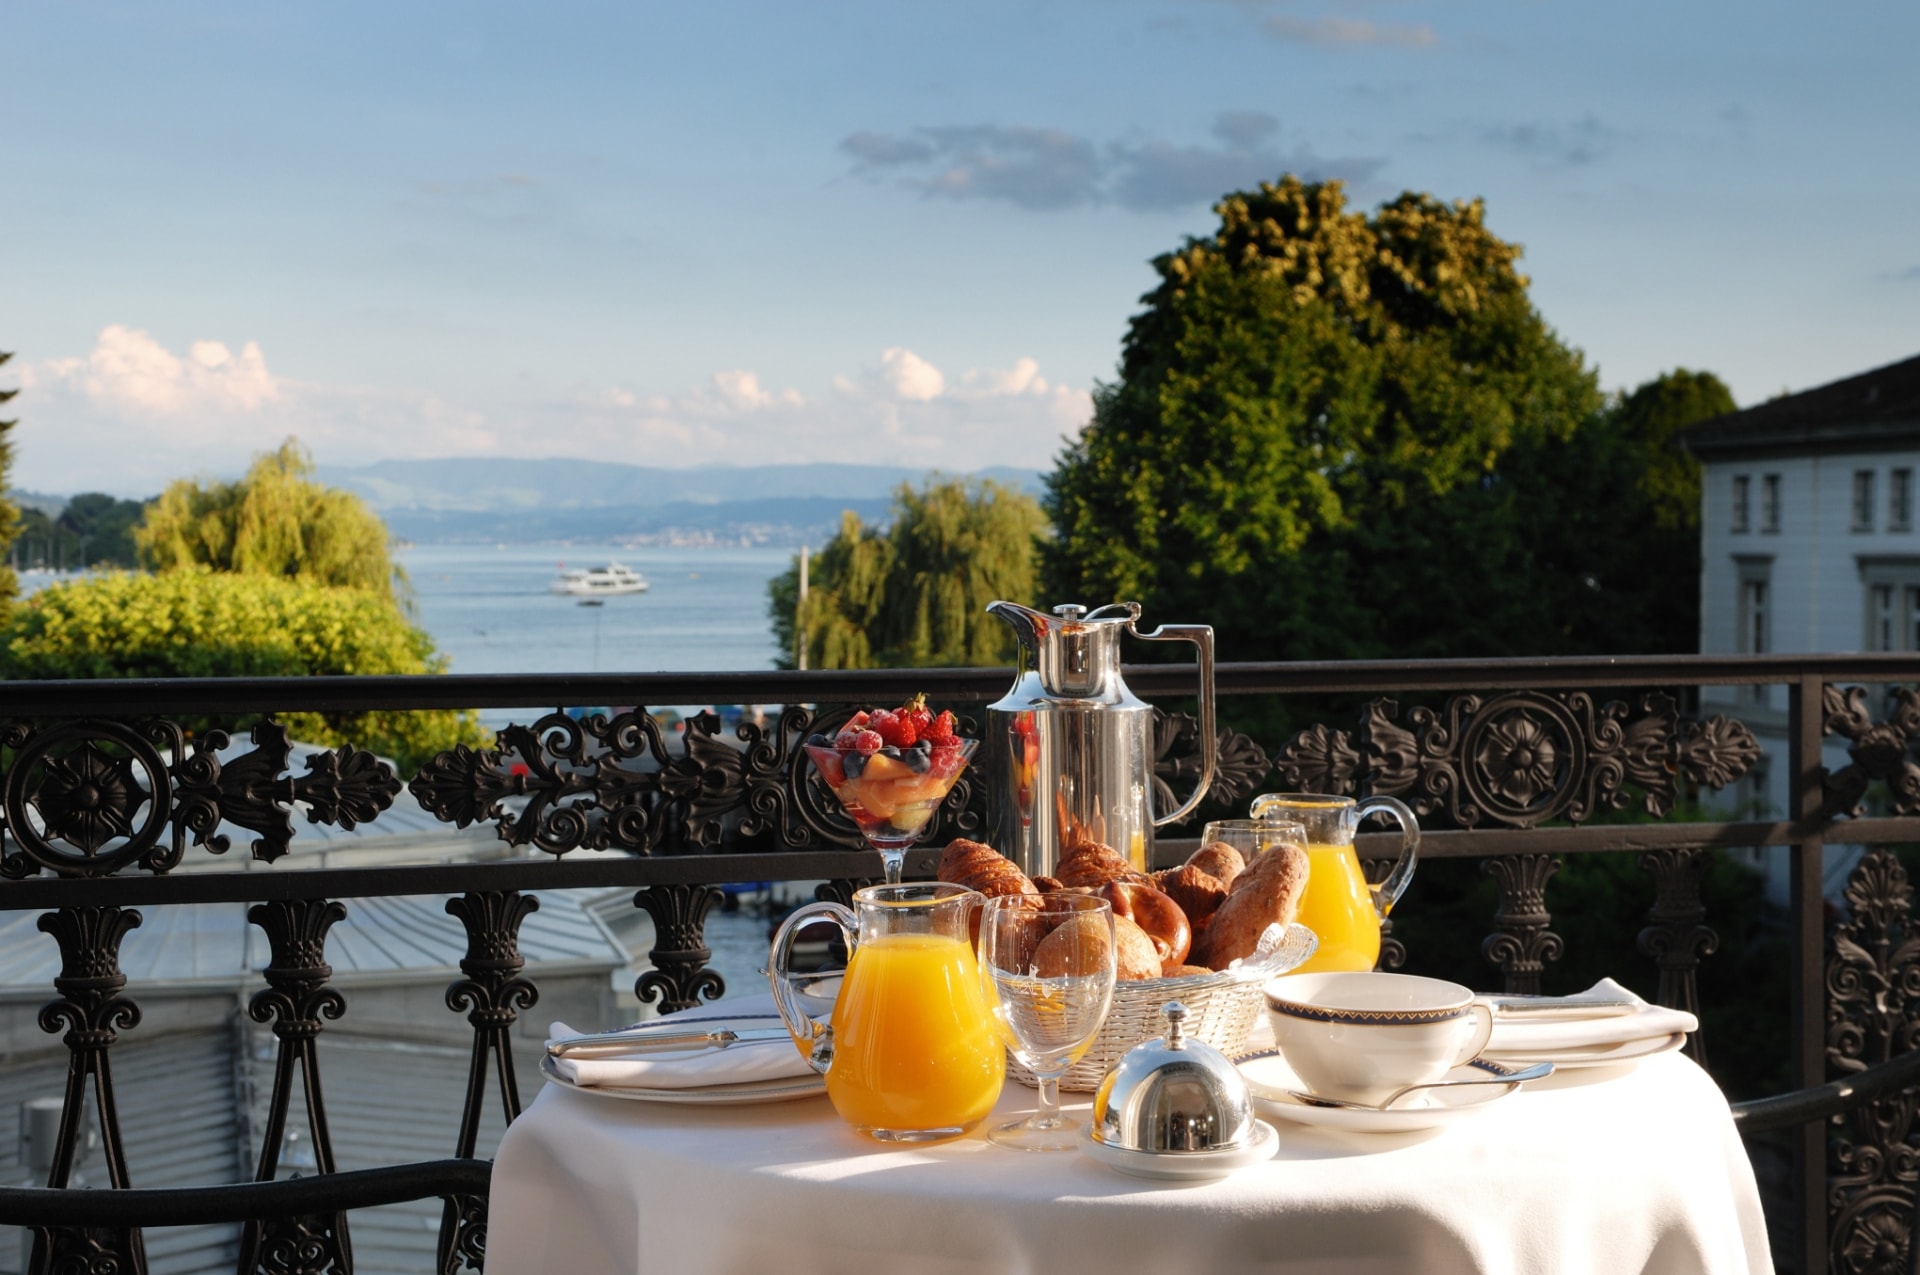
[1265,972,1494,1102]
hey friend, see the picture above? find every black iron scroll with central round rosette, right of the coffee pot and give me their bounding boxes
[1275,691,1761,828]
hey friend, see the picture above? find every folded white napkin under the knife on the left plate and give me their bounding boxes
[547,995,814,1089]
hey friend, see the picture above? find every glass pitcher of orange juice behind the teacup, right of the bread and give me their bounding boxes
[1254,793,1421,974]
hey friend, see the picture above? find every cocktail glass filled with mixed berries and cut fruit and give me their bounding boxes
[804,735,979,885]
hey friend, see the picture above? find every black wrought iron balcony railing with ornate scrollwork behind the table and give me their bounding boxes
[0,655,1920,1271]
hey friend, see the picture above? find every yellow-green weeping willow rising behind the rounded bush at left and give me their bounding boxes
[134,438,399,597]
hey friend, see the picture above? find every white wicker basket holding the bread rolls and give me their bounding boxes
[1006,926,1319,1093]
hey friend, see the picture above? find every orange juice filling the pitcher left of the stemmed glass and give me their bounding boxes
[828,933,1006,1141]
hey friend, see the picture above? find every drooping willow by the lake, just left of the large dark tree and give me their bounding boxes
[768,478,1046,668]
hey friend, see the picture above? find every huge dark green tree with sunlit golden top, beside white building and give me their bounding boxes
[1043,177,1603,659]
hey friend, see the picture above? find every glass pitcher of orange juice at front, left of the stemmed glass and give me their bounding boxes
[768,883,1006,1143]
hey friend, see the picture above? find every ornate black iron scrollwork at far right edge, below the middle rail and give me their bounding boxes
[1826,847,1920,1273]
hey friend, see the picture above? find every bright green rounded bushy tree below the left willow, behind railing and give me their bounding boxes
[0,566,482,770]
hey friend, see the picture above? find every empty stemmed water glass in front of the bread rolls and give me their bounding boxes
[979,895,1116,1150]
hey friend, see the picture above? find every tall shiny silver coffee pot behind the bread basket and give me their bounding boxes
[981,603,1217,876]
